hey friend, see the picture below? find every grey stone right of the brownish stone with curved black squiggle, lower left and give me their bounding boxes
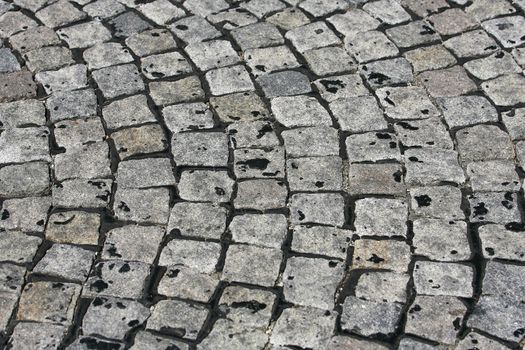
[101,225,166,264]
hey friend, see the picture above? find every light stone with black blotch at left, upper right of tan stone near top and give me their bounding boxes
[170,16,221,44]
